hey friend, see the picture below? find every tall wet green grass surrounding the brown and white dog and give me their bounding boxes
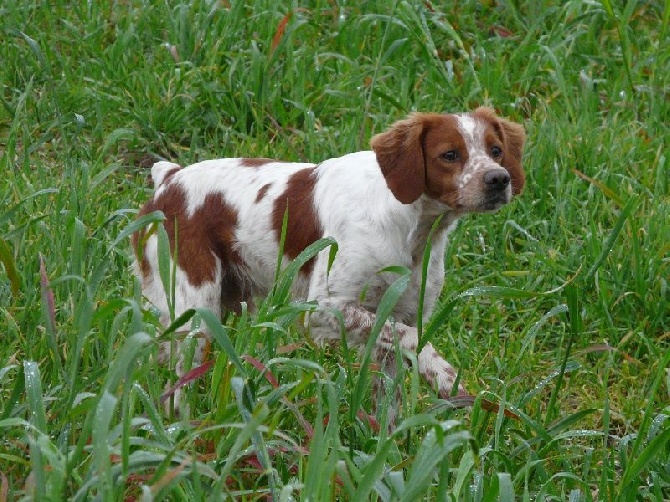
[0,0,670,501]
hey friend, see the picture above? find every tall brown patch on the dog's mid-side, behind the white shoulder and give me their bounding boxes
[272,168,323,274]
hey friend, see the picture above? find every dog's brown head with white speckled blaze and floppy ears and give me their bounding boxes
[371,108,525,212]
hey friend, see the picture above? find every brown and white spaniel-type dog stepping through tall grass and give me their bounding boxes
[132,108,525,416]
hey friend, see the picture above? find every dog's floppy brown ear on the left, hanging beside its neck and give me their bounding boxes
[370,114,426,204]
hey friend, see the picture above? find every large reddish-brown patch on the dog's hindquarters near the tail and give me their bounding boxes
[132,184,249,309]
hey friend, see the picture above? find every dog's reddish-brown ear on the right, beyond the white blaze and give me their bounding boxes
[472,108,526,195]
